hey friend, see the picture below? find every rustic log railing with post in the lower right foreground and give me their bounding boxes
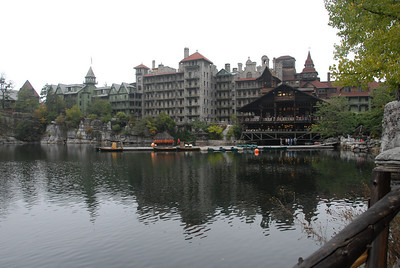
[294,167,400,268]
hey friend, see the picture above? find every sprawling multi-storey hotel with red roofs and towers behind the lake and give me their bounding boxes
[50,48,378,131]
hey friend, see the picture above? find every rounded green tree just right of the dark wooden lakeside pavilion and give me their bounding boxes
[312,97,356,137]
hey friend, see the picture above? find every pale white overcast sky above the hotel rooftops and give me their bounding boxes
[0,0,339,93]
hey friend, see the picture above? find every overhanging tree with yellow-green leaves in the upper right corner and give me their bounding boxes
[325,0,400,100]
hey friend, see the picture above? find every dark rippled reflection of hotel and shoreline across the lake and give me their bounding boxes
[0,145,373,240]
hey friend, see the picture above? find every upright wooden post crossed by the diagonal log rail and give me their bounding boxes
[367,168,391,268]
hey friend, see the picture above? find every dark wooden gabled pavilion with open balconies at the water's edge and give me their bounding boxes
[239,84,323,145]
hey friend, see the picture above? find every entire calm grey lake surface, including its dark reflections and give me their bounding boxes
[0,145,373,267]
